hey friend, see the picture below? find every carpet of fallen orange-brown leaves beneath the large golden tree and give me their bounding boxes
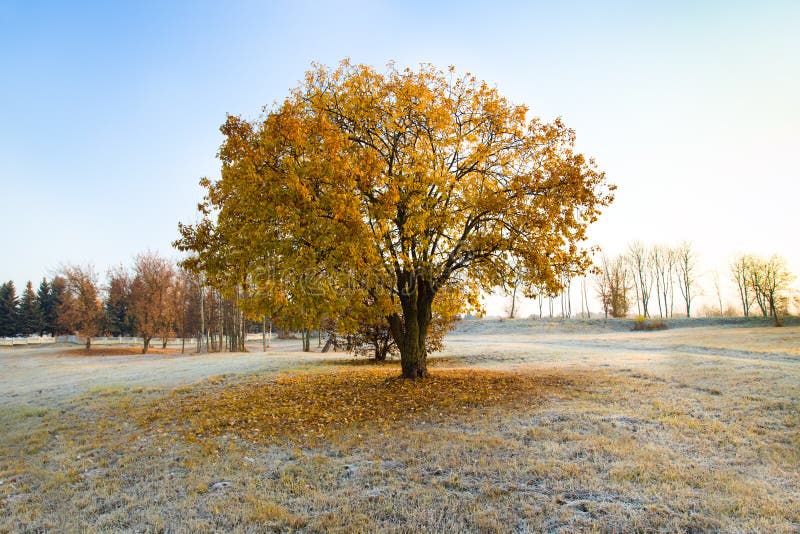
[143,367,588,444]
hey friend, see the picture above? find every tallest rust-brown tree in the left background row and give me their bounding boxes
[130,252,175,354]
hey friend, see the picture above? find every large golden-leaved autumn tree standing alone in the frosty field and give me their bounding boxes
[177,61,613,378]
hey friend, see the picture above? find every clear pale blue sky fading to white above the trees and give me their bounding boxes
[0,0,800,311]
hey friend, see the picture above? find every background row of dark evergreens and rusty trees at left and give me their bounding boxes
[0,253,245,353]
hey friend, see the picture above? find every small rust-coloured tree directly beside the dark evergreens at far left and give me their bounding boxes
[58,265,103,351]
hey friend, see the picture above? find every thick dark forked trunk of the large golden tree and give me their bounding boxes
[388,272,435,379]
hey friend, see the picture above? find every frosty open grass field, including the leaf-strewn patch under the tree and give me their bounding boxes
[0,320,800,532]
